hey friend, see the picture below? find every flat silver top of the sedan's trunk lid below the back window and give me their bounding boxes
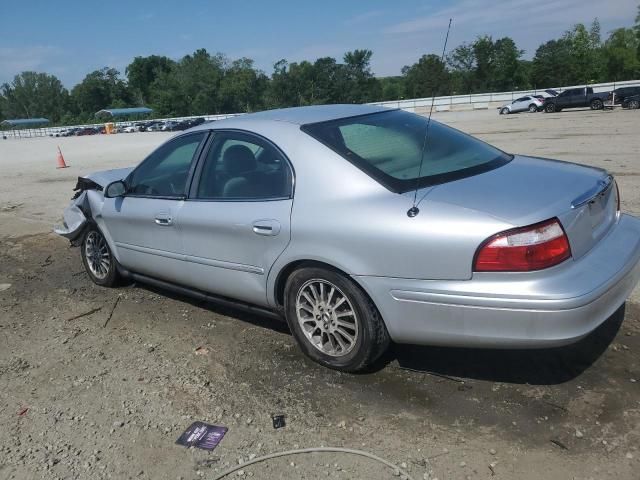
[426,155,606,226]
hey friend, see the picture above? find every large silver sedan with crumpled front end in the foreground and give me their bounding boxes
[56,105,640,371]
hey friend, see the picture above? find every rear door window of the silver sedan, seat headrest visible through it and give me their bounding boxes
[196,132,291,200]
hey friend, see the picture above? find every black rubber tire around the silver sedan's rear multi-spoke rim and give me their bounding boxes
[284,267,390,372]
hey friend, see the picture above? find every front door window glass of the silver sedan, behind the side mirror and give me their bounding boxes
[127,132,207,197]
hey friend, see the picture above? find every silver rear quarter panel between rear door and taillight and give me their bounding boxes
[262,127,511,302]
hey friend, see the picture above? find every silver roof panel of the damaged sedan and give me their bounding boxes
[200,105,389,128]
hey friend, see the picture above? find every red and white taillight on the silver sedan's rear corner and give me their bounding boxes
[473,218,571,272]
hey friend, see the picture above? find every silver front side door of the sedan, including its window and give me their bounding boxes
[102,132,208,282]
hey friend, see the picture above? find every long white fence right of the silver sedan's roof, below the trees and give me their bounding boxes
[371,80,640,113]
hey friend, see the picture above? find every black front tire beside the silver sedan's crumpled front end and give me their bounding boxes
[80,225,121,287]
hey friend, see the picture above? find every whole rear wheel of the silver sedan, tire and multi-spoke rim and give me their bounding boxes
[285,267,389,372]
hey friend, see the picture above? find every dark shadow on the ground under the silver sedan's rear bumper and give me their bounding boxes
[384,305,625,385]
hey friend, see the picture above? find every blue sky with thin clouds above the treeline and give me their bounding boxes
[0,0,640,88]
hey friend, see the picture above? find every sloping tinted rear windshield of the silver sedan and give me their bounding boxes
[302,110,512,193]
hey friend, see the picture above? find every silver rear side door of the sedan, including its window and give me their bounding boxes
[180,131,293,305]
